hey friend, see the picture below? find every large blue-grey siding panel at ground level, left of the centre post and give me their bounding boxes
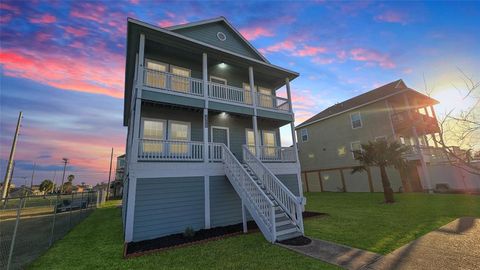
[133,176,205,241]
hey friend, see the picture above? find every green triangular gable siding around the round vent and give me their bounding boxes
[173,22,263,61]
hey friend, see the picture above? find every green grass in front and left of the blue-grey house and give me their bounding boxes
[29,199,338,269]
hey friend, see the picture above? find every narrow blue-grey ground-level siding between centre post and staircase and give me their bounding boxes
[210,175,242,228]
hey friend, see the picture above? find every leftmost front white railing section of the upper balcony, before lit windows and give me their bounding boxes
[143,69,203,96]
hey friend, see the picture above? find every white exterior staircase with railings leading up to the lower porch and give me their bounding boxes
[222,145,303,243]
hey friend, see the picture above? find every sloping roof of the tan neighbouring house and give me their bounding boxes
[296,79,439,129]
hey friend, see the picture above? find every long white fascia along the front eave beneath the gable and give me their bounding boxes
[128,18,300,77]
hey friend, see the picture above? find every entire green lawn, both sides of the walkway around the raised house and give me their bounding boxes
[31,193,480,269]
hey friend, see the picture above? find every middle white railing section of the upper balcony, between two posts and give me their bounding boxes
[208,82,252,105]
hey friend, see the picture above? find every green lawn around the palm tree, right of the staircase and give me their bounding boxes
[305,193,480,254]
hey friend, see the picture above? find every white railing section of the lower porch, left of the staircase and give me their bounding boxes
[138,139,203,161]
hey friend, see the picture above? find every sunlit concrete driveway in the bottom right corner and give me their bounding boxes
[364,217,480,270]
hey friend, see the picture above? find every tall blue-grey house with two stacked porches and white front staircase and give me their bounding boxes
[123,17,304,243]
